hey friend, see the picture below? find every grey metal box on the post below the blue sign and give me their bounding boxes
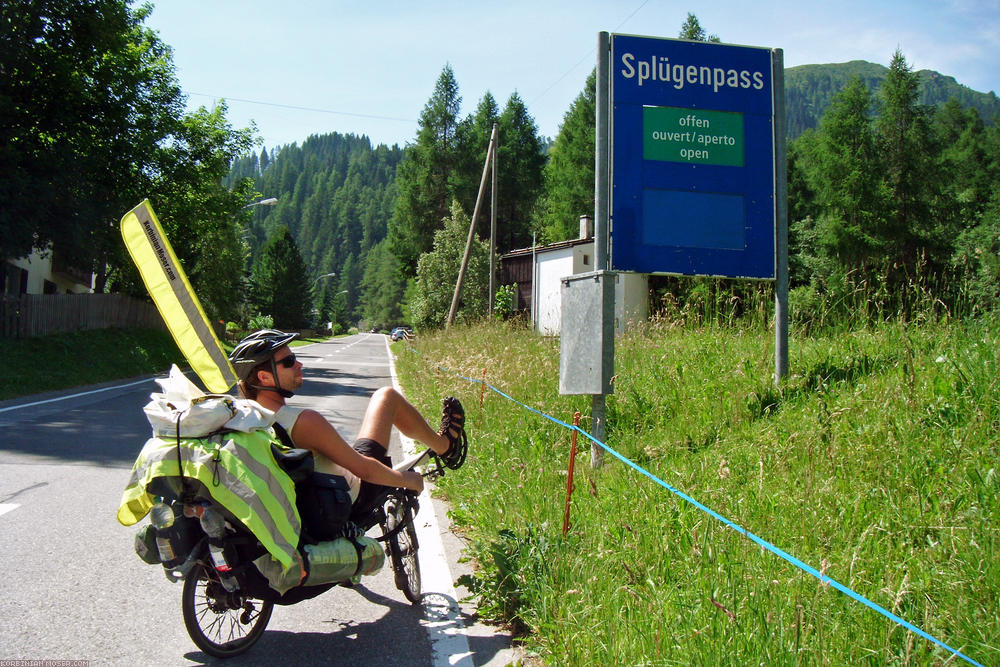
[559,271,615,394]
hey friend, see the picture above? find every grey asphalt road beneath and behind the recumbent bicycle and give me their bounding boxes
[0,334,517,666]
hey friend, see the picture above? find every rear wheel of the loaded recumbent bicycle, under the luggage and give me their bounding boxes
[181,563,274,658]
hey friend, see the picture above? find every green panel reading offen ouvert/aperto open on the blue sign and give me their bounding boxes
[642,107,743,167]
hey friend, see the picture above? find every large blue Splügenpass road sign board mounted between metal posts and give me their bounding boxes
[611,35,775,279]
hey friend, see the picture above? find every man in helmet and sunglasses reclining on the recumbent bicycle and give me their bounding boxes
[229,329,465,507]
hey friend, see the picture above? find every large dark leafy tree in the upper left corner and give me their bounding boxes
[0,0,184,269]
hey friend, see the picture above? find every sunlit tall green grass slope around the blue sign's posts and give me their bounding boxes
[393,320,1000,665]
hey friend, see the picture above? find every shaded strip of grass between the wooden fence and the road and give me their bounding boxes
[0,329,183,400]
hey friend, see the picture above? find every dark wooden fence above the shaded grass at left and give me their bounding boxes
[0,294,166,338]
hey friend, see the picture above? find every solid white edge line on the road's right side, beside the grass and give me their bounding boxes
[385,338,474,667]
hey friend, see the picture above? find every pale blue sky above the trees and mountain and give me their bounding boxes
[147,0,1000,148]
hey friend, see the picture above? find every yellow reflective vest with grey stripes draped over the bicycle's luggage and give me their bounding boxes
[118,430,302,570]
